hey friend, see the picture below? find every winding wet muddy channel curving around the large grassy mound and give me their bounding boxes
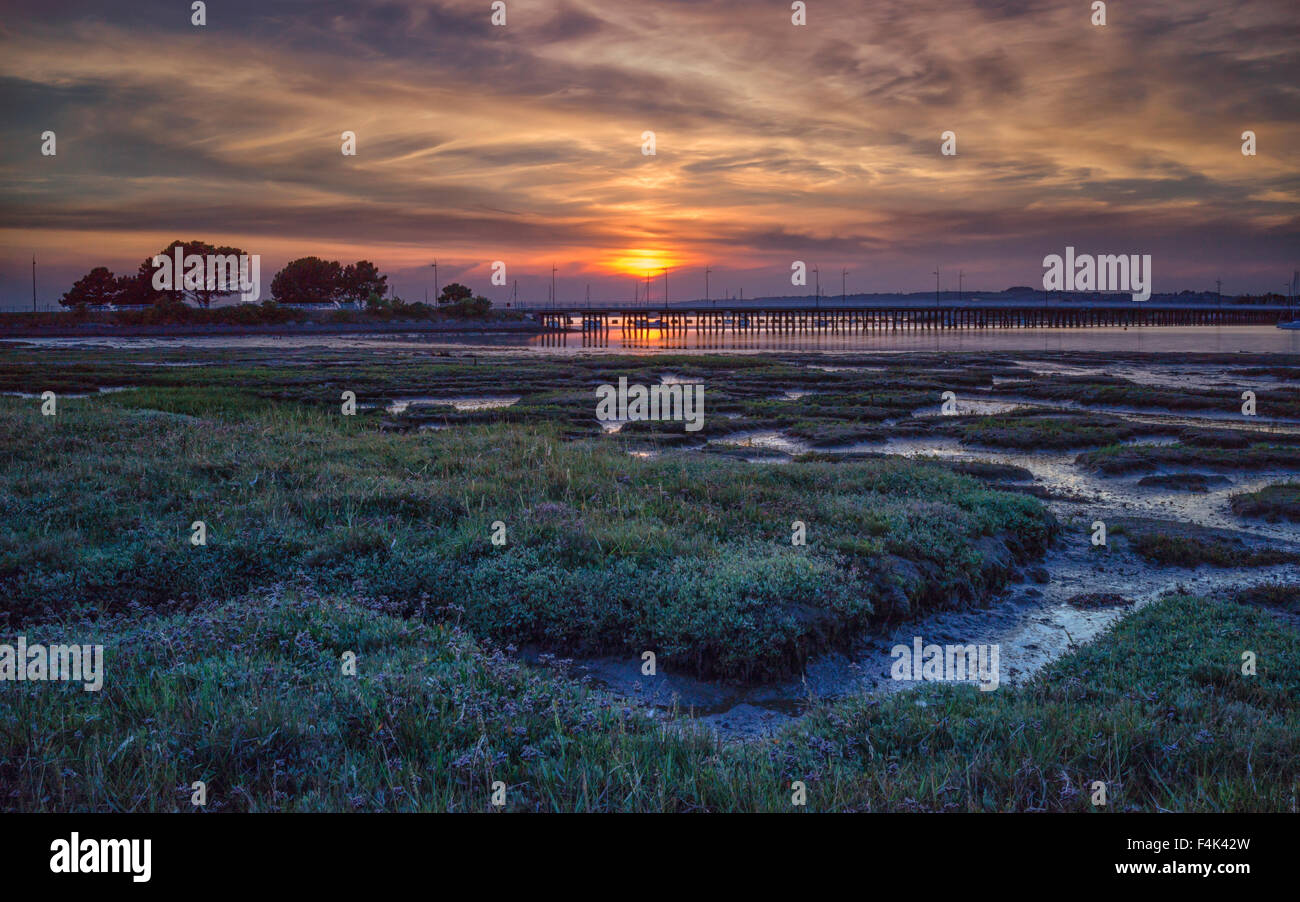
[579,423,1300,740]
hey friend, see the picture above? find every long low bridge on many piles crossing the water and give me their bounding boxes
[533,302,1291,334]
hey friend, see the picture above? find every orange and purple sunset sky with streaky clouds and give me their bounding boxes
[0,0,1300,307]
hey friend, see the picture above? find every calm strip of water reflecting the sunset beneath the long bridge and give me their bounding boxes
[10,326,1300,354]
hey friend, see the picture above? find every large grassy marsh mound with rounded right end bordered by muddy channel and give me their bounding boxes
[0,392,1056,680]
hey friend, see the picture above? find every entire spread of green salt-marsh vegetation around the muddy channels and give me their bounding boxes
[0,350,1300,811]
